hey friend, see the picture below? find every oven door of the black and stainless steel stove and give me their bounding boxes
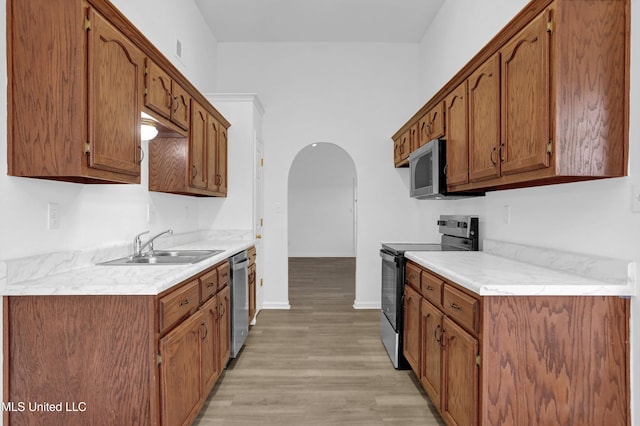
[380,250,404,332]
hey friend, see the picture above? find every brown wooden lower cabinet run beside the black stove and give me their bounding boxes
[404,264,631,426]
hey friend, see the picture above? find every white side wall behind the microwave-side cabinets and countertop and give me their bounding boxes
[419,0,640,425]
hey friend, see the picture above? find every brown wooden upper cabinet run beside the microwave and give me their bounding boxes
[394,0,630,192]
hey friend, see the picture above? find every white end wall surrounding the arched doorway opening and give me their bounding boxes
[218,43,419,308]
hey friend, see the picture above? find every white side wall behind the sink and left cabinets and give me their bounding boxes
[0,0,221,259]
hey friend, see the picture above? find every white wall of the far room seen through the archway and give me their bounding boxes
[288,143,357,257]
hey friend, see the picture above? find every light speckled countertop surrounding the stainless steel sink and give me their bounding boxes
[0,230,254,296]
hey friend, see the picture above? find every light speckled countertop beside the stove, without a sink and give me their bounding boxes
[405,241,637,296]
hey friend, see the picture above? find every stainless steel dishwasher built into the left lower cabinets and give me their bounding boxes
[229,250,249,358]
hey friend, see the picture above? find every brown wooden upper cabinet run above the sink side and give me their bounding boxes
[7,0,230,191]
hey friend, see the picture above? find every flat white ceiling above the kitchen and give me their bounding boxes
[195,0,445,43]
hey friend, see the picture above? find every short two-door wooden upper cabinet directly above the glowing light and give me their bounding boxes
[144,58,191,130]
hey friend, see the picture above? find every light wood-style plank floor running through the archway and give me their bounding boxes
[194,258,443,426]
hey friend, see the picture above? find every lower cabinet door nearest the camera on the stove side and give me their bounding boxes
[441,316,479,426]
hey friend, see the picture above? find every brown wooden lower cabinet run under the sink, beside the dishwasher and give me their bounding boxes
[3,261,230,425]
